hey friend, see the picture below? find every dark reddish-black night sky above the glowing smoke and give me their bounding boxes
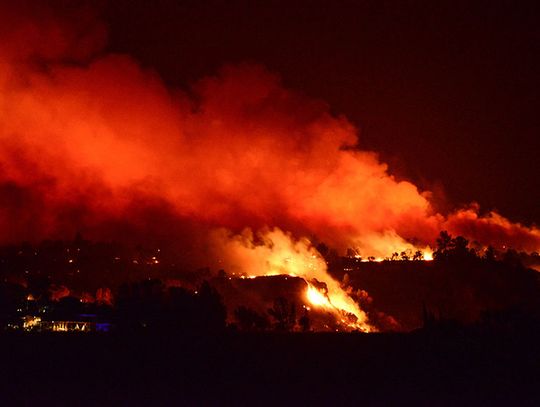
[102,0,540,224]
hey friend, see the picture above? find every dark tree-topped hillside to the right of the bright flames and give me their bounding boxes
[338,231,540,330]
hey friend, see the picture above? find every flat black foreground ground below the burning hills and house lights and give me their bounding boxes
[0,329,540,406]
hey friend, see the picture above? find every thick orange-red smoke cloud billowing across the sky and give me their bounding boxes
[0,3,540,264]
